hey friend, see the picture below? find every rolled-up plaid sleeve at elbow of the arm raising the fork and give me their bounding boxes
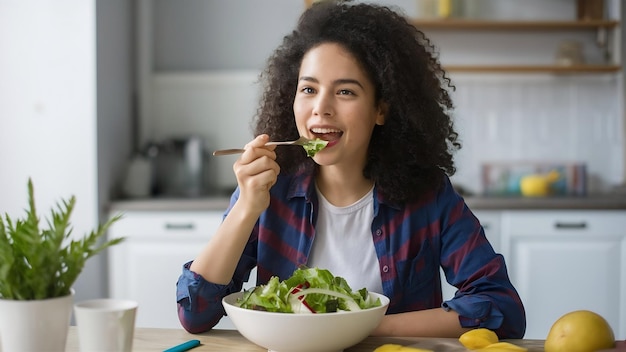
[176,262,241,334]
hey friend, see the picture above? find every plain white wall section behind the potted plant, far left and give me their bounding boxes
[0,0,132,300]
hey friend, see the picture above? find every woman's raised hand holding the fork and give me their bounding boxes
[233,134,280,214]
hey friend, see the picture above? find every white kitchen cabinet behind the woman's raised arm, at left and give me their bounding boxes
[109,211,256,329]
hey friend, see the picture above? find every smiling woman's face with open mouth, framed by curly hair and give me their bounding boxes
[293,43,384,172]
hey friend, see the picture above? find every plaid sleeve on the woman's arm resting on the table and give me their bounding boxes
[439,179,526,338]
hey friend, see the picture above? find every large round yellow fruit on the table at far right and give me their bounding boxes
[544,310,615,352]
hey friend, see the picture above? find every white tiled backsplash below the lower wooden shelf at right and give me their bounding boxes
[452,74,625,193]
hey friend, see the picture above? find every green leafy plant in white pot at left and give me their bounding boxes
[0,179,123,352]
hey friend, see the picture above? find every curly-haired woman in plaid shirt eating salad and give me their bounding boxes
[177,1,526,338]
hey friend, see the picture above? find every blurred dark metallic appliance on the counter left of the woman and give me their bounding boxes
[153,136,209,197]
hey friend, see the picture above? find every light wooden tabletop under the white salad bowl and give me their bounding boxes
[66,326,543,352]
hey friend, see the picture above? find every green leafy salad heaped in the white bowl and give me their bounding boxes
[237,266,381,313]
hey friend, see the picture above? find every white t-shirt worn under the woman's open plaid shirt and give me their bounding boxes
[307,187,383,293]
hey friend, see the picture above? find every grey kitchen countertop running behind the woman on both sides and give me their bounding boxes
[109,194,626,212]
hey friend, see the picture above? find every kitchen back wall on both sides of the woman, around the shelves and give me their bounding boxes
[140,0,625,197]
